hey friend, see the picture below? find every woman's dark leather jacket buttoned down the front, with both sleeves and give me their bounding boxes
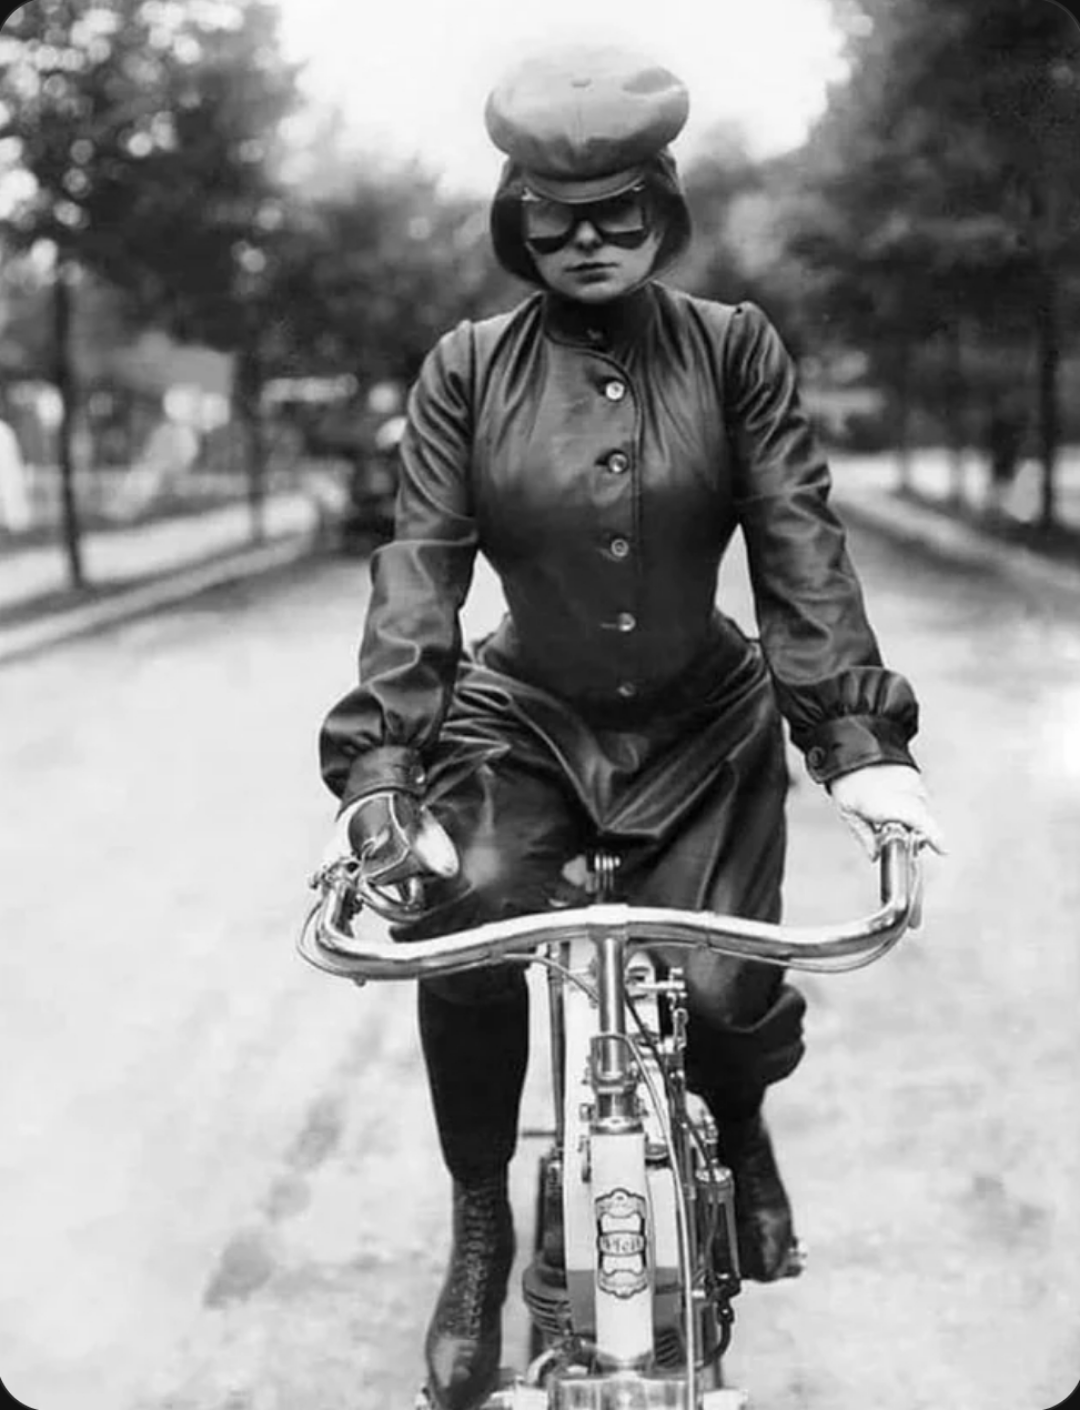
[321,282,918,802]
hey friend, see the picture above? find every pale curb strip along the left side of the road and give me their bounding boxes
[0,533,316,667]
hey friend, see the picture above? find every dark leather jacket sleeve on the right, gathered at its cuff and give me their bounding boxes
[725,303,918,784]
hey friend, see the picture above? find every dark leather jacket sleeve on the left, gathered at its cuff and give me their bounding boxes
[319,323,477,807]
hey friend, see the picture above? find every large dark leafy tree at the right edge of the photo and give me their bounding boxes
[791,0,1080,526]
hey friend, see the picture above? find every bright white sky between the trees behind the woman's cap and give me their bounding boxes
[278,0,842,192]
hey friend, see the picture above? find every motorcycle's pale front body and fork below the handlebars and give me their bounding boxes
[526,854,746,1410]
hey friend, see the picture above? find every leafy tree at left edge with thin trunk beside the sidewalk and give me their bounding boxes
[0,0,300,585]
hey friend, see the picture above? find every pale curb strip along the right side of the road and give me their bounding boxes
[835,486,1080,594]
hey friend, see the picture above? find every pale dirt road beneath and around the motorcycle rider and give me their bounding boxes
[0,524,1080,1410]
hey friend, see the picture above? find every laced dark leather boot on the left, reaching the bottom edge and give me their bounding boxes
[424,1170,513,1410]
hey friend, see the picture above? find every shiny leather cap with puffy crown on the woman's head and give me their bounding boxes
[484,47,689,202]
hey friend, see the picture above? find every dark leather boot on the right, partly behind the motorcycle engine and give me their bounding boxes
[716,1111,802,1283]
